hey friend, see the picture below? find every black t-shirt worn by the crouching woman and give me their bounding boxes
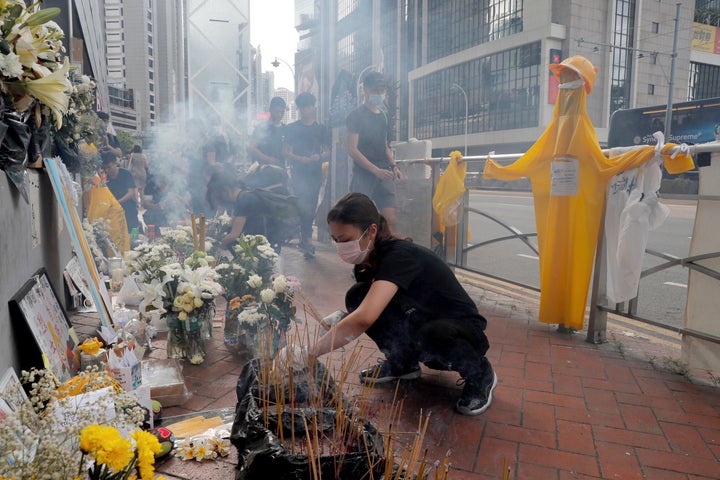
[355,240,487,330]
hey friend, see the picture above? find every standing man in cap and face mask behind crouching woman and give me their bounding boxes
[346,72,403,233]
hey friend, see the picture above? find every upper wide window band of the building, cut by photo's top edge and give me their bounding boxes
[427,0,523,61]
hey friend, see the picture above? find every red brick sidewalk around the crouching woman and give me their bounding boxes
[69,246,720,480]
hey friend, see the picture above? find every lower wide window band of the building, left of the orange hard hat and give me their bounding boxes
[412,42,545,139]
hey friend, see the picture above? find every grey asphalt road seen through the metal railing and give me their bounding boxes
[468,191,696,327]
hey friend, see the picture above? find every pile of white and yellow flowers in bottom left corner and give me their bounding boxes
[0,369,160,480]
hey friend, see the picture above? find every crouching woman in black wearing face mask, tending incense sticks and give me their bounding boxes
[307,193,497,415]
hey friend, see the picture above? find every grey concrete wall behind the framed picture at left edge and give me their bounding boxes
[0,170,72,373]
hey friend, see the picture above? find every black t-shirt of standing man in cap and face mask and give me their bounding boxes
[346,105,390,168]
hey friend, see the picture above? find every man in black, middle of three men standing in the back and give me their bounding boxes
[283,92,330,258]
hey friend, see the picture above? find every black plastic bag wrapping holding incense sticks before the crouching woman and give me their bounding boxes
[230,359,385,480]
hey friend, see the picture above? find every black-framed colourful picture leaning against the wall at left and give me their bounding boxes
[8,268,80,382]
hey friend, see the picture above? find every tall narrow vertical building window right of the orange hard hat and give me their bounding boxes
[610,0,635,113]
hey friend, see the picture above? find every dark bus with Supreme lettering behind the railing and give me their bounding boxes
[607,97,720,148]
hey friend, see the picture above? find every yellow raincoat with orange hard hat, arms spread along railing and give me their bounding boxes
[483,57,693,330]
